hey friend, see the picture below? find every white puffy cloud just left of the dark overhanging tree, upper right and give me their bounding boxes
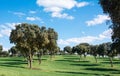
[86,15,110,26]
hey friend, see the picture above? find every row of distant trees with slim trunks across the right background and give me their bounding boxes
[64,42,119,67]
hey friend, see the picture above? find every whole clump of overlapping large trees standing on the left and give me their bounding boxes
[9,23,58,68]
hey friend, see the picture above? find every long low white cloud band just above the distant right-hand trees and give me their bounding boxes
[58,29,112,45]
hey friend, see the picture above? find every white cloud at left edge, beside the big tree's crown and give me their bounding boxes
[0,23,20,37]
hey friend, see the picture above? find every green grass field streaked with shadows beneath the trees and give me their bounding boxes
[0,55,120,76]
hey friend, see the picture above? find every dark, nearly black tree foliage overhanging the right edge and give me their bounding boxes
[99,0,120,54]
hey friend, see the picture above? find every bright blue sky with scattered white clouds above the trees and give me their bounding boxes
[0,0,112,50]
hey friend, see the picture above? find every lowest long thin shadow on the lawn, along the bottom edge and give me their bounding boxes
[56,71,110,76]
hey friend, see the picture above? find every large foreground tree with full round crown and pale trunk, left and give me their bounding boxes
[10,23,43,69]
